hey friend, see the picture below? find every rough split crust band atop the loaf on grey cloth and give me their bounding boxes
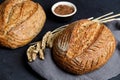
[67,22,102,58]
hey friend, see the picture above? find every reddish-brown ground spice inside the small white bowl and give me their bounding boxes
[54,5,74,15]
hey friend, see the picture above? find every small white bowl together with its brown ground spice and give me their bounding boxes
[51,1,77,21]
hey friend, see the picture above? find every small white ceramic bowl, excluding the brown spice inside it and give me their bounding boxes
[51,1,77,21]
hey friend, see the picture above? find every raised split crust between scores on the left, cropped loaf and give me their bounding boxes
[4,1,38,35]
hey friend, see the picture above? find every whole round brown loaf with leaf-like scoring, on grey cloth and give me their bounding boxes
[53,19,116,74]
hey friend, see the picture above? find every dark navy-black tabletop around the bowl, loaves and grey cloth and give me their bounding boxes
[0,0,120,80]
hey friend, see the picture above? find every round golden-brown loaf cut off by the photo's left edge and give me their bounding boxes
[0,0,46,48]
